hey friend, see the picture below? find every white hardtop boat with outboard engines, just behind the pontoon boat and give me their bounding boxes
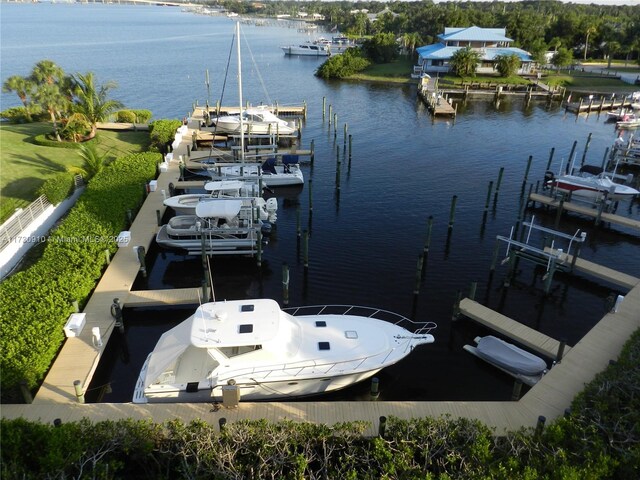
[163,180,278,224]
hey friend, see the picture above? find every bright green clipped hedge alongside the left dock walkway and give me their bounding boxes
[0,153,161,398]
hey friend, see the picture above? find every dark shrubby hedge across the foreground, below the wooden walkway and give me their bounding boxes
[0,331,640,480]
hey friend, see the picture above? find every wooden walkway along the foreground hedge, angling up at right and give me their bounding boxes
[2,286,640,435]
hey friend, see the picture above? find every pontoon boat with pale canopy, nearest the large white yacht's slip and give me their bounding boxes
[156,198,269,255]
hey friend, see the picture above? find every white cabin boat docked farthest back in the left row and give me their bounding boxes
[211,105,298,135]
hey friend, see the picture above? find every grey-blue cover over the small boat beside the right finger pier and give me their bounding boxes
[476,335,547,375]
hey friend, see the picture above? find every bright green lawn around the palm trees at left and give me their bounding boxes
[0,123,149,222]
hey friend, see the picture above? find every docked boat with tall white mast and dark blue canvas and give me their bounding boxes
[207,22,304,187]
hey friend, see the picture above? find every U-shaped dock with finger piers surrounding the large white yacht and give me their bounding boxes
[2,110,640,435]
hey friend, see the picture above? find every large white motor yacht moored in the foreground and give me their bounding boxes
[133,299,436,403]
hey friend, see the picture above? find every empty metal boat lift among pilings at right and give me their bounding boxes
[491,216,587,294]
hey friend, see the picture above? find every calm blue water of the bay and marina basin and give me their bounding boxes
[0,4,640,402]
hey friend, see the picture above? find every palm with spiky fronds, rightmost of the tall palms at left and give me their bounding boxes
[73,72,123,138]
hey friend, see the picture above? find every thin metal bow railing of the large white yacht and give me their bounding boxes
[282,305,437,335]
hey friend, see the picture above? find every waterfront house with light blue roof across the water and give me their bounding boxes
[414,26,534,74]
